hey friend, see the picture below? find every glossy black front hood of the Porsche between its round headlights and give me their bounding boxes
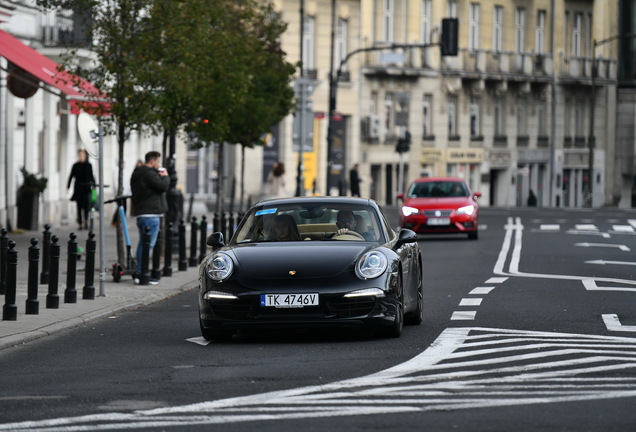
[230,240,373,279]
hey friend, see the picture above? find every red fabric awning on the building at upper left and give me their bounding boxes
[0,30,103,114]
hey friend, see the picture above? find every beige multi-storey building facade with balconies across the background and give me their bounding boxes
[274,0,620,207]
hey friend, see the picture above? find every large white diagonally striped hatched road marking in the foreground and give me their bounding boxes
[0,327,636,432]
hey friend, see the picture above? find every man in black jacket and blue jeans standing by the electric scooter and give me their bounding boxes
[130,151,170,285]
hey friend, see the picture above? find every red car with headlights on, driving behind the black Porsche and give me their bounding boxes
[398,177,481,240]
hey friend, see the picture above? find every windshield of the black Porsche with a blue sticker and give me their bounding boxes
[232,203,385,244]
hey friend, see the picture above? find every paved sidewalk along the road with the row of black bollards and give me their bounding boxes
[0,218,198,350]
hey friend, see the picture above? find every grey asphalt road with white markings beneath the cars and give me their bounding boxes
[0,209,636,432]
